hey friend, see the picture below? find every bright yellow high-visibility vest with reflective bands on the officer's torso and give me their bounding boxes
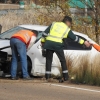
[46,22,70,43]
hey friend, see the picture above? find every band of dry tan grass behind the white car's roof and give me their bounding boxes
[0,9,63,32]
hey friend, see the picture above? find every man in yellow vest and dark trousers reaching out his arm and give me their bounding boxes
[41,16,91,81]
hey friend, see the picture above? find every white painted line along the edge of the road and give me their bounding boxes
[44,83,100,93]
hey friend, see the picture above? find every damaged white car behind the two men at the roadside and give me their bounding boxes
[0,25,98,76]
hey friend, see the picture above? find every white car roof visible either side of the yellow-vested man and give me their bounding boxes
[19,25,88,38]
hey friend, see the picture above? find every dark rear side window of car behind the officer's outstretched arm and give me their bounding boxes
[64,35,92,50]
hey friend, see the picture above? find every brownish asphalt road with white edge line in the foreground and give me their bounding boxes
[0,80,100,100]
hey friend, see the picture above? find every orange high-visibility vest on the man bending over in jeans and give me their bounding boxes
[12,30,35,44]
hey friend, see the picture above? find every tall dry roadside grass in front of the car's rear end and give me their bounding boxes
[67,53,100,86]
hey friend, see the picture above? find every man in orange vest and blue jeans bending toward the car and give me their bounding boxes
[10,30,37,80]
